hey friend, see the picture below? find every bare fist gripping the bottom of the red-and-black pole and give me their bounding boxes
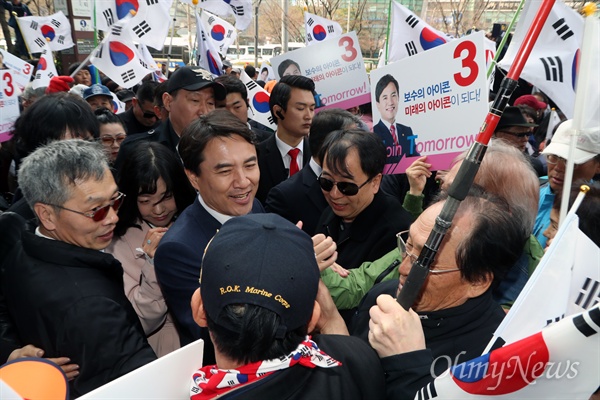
[369,294,425,358]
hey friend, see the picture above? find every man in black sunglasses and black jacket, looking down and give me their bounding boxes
[317,129,412,269]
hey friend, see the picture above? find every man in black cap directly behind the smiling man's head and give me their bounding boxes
[115,67,227,168]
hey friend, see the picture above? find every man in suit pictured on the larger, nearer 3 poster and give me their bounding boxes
[373,74,419,164]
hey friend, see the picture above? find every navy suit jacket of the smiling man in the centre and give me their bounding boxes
[154,197,264,365]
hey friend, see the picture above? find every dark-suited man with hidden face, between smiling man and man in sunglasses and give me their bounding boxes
[265,108,360,235]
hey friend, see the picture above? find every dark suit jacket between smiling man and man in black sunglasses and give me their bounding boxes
[265,165,327,236]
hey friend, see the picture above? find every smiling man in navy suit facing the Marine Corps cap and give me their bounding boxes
[154,110,264,363]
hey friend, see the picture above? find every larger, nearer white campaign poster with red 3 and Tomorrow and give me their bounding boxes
[371,32,488,174]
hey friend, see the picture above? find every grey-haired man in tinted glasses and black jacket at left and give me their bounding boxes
[0,140,156,397]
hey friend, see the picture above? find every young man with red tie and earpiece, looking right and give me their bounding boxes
[256,75,315,202]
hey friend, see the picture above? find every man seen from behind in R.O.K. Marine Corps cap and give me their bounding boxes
[190,214,385,400]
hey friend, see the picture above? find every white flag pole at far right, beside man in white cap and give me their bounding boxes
[558,10,599,226]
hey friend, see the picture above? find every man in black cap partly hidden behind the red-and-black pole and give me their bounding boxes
[494,107,546,176]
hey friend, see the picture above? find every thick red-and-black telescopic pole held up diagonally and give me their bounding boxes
[397,0,555,310]
